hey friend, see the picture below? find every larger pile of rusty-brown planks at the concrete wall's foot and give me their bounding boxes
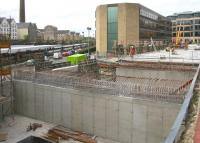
[43,126,97,143]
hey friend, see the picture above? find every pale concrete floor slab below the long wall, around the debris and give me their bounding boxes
[0,115,119,143]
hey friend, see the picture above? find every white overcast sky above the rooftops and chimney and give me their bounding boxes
[0,0,200,33]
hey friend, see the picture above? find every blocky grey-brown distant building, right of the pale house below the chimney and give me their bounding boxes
[44,25,58,41]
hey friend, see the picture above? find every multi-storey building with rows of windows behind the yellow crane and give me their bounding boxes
[168,11,200,43]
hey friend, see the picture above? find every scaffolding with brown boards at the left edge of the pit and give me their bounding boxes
[0,32,14,119]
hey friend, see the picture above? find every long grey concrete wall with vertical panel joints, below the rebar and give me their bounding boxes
[14,81,180,143]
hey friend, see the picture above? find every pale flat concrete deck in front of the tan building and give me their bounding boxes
[98,49,200,63]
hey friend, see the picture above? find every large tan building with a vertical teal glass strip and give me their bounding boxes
[96,3,171,53]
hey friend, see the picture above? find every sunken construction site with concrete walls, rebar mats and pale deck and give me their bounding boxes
[0,37,199,143]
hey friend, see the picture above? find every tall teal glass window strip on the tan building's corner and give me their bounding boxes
[107,7,118,51]
